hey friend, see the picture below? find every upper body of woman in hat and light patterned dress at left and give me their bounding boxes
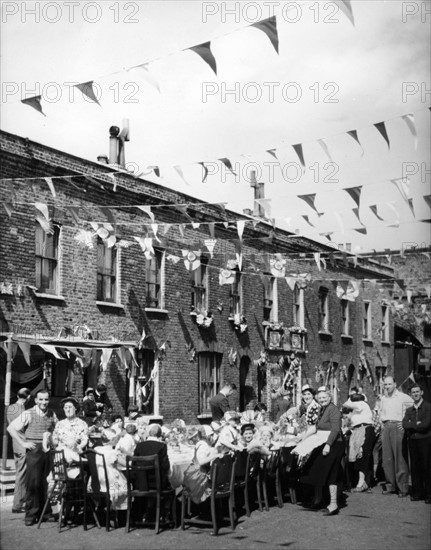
[52,397,88,462]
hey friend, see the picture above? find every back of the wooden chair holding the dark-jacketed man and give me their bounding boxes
[126,454,162,494]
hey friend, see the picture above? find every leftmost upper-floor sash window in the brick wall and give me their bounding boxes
[36,223,60,294]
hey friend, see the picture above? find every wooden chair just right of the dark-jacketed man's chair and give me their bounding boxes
[181,455,235,535]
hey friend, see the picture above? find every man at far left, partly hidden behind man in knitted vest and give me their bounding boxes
[6,388,31,514]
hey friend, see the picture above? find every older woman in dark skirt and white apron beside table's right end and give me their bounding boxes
[301,386,345,516]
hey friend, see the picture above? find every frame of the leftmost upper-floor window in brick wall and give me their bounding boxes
[35,222,61,296]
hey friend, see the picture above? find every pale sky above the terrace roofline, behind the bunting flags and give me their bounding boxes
[1,0,431,251]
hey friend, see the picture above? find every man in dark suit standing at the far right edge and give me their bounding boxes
[403,384,431,504]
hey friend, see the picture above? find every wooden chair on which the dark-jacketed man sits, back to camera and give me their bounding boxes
[126,455,177,534]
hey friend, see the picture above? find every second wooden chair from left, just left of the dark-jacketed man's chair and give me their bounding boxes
[82,449,118,531]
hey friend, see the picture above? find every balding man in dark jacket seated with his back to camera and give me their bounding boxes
[134,424,171,523]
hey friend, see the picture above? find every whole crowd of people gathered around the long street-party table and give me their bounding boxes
[4,376,431,526]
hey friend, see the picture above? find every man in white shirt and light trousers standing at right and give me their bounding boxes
[380,376,413,497]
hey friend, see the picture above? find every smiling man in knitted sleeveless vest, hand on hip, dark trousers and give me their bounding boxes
[8,390,57,526]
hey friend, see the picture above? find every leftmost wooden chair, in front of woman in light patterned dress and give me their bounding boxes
[37,450,100,532]
